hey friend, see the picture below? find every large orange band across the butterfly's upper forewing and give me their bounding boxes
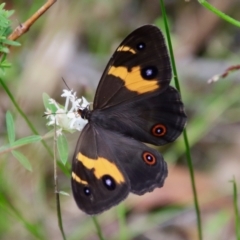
[108,66,159,94]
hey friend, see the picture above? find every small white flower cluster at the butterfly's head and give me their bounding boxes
[45,89,89,135]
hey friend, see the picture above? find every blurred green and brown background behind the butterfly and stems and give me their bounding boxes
[0,0,240,240]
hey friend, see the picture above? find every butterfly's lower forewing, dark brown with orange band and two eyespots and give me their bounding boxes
[72,124,129,214]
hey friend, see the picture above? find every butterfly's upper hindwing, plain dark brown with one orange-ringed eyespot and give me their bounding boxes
[91,86,187,145]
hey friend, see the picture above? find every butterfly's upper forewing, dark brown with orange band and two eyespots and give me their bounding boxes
[93,25,171,109]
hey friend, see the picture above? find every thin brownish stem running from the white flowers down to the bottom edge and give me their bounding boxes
[53,120,66,240]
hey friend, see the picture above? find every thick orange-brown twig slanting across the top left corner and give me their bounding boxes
[8,0,57,40]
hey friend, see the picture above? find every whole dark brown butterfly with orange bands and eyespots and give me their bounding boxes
[71,25,187,215]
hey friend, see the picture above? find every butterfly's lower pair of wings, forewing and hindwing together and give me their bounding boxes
[72,124,167,214]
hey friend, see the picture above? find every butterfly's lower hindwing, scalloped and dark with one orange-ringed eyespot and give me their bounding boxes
[92,126,167,195]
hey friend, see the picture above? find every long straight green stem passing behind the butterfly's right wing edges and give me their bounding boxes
[160,0,203,240]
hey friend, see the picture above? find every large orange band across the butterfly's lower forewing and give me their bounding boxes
[76,153,125,183]
